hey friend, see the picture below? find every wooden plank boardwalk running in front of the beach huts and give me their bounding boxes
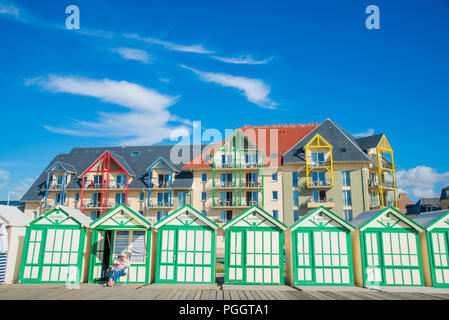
[0,284,449,300]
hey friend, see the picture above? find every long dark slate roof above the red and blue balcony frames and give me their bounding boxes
[22,145,207,201]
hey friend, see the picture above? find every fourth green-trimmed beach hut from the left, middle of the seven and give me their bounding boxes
[223,206,287,285]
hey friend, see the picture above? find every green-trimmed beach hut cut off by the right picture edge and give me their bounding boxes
[413,209,449,288]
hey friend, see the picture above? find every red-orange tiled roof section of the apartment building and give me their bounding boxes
[183,123,318,169]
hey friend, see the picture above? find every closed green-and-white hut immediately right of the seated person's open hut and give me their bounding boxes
[154,205,218,283]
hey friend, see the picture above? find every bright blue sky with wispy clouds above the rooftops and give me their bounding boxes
[0,0,449,199]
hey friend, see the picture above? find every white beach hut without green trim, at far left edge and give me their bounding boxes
[0,206,31,284]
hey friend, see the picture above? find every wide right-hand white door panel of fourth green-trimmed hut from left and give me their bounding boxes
[246,230,281,284]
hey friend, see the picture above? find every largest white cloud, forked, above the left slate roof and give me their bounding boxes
[26,75,190,145]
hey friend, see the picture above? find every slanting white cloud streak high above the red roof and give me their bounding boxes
[181,65,277,109]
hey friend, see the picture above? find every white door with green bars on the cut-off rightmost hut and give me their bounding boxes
[431,232,449,284]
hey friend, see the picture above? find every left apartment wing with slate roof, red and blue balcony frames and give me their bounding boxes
[22,146,207,221]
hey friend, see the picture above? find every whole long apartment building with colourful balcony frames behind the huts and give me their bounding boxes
[22,119,397,229]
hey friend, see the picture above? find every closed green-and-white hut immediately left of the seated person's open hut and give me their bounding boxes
[19,206,92,283]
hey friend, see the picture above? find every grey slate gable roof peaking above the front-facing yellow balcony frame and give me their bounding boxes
[282,119,371,163]
